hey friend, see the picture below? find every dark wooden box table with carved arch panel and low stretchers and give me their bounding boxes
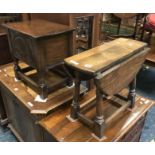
[3,19,74,99]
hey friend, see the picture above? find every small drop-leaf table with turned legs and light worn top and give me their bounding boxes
[65,38,149,139]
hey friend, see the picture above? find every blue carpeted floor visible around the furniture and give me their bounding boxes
[0,65,155,142]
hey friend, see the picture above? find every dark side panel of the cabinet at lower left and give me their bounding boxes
[2,86,43,142]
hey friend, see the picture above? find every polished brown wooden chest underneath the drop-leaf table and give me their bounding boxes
[39,90,154,142]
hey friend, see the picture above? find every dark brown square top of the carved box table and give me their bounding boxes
[3,19,74,38]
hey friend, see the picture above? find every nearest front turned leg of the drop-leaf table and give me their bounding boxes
[94,89,105,138]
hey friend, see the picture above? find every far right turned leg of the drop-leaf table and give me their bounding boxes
[128,78,136,108]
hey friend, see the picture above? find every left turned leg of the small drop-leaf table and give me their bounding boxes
[71,73,81,119]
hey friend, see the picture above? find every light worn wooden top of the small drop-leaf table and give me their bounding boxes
[64,38,147,74]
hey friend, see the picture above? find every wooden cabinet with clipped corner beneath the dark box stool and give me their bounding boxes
[0,63,85,142]
